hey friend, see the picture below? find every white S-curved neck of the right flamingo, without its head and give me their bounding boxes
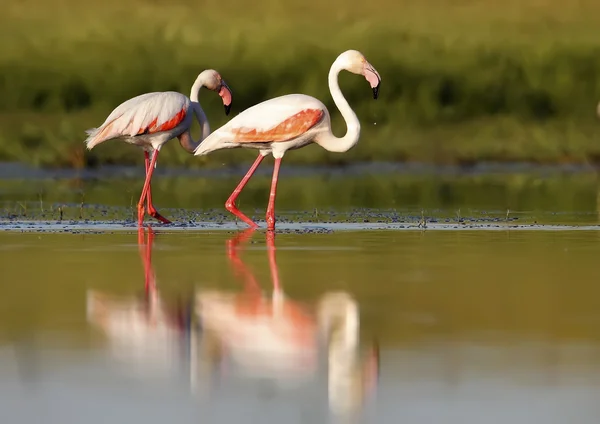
[315,62,360,153]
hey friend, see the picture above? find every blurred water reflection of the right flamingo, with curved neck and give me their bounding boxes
[195,228,379,415]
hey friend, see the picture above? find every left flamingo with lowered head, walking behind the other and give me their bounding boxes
[85,69,232,227]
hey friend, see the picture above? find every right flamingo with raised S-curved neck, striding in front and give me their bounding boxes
[194,50,381,230]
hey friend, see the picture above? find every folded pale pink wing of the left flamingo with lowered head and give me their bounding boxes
[85,91,190,149]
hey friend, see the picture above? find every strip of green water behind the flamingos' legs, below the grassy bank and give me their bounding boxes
[0,171,600,225]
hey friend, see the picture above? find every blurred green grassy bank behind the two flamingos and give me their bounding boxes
[0,0,600,167]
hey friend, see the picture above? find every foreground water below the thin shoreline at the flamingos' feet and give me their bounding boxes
[0,229,600,423]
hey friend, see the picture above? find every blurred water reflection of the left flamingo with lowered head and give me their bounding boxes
[87,228,191,377]
